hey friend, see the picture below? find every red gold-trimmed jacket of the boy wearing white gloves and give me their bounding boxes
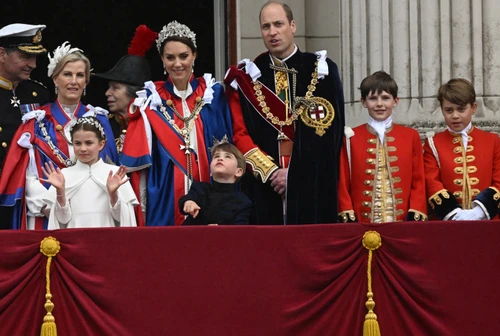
[424,127,500,218]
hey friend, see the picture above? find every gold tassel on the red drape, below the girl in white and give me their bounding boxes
[40,237,61,336]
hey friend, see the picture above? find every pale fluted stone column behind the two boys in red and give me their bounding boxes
[341,0,500,132]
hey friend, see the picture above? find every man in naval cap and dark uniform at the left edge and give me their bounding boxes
[0,23,49,228]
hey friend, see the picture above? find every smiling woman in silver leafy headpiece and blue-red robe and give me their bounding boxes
[120,21,232,226]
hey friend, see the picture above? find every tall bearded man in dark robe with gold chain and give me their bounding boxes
[225,1,345,224]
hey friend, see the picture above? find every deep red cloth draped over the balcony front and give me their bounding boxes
[0,221,500,336]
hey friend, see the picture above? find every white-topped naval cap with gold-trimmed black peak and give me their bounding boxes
[0,23,47,54]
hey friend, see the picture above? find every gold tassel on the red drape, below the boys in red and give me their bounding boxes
[363,231,382,336]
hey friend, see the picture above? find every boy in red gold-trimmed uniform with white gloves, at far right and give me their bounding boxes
[424,78,500,220]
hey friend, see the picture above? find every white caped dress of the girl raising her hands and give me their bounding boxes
[44,159,139,230]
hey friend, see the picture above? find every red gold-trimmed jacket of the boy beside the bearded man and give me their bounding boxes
[339,124,427,223]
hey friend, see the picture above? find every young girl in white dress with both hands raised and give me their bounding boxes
[40,117,139,230]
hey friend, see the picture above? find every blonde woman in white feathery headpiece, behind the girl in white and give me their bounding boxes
[0,42,118,229]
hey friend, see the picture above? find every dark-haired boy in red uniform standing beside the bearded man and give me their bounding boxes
[339,71,427,223]
